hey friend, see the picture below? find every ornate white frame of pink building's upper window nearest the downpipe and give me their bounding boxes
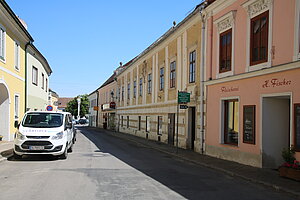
[214,10,236,78]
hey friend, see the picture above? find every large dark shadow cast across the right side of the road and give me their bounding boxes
[79,128,274,199]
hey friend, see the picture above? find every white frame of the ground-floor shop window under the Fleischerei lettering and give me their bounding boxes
[219,96,242,147]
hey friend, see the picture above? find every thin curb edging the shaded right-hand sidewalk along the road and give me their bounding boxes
[89,127,300,197]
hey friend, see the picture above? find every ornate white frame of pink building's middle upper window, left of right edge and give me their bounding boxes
[242,0,273,72]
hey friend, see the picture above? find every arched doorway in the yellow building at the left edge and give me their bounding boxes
[0,80,9,140]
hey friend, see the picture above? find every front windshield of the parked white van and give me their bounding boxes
[22,113,63,128]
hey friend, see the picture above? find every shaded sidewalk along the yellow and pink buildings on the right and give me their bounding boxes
[89,127,300,199]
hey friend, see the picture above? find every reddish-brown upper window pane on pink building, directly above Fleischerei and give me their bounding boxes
[219,29,232,73]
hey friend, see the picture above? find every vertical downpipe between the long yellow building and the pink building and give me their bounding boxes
[200,4,206,154]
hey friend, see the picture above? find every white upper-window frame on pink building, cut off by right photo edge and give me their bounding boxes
[293,0,300,61]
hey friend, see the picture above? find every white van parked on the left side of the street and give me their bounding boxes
[14,111,75,159]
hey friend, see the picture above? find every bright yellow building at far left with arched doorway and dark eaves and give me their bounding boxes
[0,1,33,141]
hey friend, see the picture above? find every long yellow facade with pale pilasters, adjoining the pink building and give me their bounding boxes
[116,8,202,152]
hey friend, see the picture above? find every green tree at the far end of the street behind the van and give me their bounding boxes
[66,94,89,117]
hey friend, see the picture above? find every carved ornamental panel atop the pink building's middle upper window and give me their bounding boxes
[243,0,273,18]
